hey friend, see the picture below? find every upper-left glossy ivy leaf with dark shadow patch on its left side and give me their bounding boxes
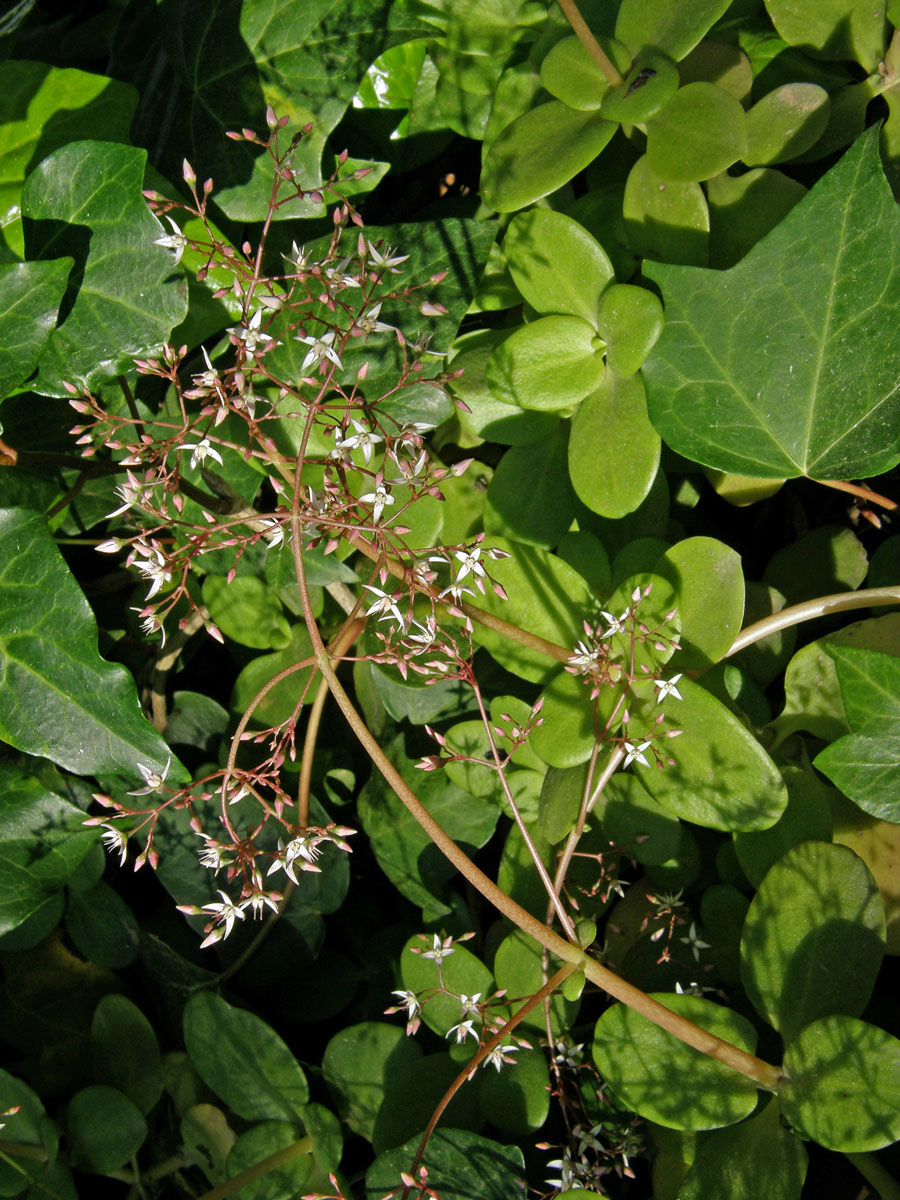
[22,142,187,396]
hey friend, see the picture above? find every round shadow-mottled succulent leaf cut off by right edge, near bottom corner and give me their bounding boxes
[779,1014,900,1153]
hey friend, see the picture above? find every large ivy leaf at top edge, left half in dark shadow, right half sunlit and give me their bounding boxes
[120,0,431,221]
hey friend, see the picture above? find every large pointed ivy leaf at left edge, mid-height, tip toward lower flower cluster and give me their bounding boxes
[0,509,187,782]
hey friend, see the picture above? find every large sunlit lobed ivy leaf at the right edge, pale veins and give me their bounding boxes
[643,128,900,479]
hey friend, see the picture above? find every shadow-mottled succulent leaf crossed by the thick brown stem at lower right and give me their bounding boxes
[593,992,756,1129]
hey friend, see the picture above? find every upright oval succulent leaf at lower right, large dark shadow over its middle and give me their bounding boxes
[740,841,884,1042]
